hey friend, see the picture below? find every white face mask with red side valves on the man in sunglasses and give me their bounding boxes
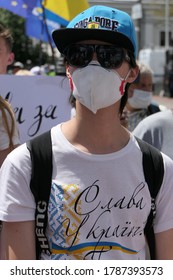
[72,61,130,114]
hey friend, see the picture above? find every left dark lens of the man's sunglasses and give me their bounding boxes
[66,45,93,67]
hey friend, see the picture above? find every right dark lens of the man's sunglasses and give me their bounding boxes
[97,46,125,68]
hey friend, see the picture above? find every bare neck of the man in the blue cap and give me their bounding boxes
[62,107,130,154]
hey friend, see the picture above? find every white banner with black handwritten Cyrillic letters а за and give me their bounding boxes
[0,75,71,143]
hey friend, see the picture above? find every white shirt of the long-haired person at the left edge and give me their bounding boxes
[0,111,20,151]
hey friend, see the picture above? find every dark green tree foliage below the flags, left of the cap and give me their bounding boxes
[0,8,51,65]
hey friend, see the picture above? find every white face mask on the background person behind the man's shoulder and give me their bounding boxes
[128,89,152,109]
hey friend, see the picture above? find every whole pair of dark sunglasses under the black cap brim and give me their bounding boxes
[64,44,130,69]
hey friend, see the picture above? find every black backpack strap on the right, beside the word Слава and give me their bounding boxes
[135,137,164,259]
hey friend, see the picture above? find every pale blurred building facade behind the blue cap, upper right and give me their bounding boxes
[88,0,173,54]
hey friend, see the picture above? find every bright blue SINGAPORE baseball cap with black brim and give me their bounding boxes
[52,5,137,57]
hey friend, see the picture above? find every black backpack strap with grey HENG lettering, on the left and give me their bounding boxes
[26,131,52,259]
